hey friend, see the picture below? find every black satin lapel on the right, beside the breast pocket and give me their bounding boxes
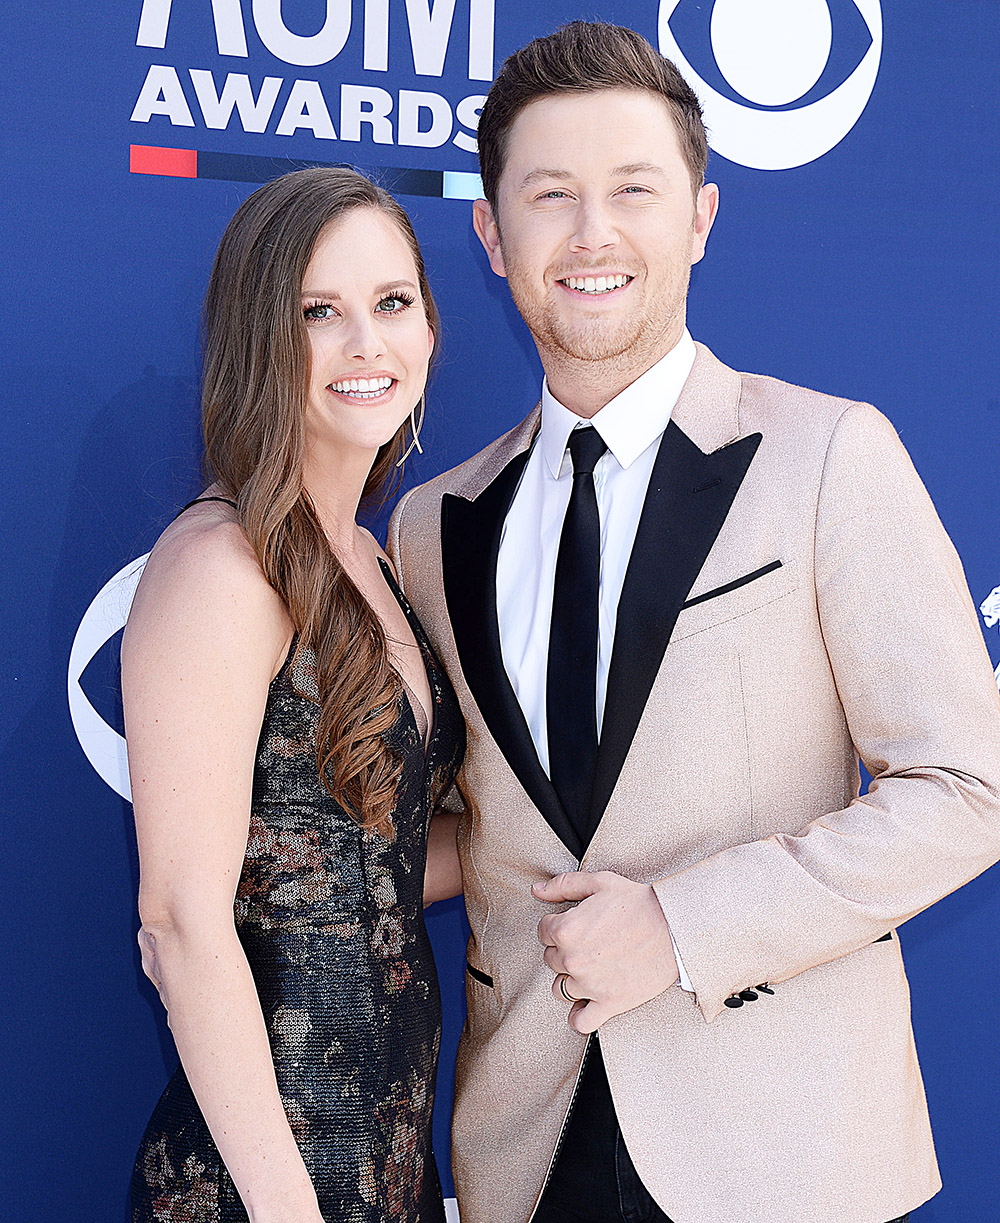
[590,421,760,833]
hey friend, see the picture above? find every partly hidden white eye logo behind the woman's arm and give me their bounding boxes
[67,553,149,801]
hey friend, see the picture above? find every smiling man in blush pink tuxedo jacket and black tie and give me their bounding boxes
[390,23,1000,1223]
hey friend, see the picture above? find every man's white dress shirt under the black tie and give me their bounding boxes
[496,330,694,989]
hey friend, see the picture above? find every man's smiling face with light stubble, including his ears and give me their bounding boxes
[474,89,718,367]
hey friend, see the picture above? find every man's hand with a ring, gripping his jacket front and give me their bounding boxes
[532,871,677,1033]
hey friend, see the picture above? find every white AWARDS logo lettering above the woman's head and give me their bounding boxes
[131,0,496,154]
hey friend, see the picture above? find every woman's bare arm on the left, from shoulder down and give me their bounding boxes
[122,511,322,1223]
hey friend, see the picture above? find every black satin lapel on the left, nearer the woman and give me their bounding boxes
[441,451,582,857]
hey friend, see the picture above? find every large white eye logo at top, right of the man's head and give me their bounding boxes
[659,0,881,170]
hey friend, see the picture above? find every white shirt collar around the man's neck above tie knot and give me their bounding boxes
[538,328,694,479]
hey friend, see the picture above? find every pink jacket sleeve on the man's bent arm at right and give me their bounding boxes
[653,404,1000,1020]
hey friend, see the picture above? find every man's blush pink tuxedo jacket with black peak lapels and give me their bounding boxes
[390,346,1000,1223]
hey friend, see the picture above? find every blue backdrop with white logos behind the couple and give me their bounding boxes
[0,0,1000,1223]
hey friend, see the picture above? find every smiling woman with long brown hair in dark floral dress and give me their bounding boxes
[122,169,465,1223]
